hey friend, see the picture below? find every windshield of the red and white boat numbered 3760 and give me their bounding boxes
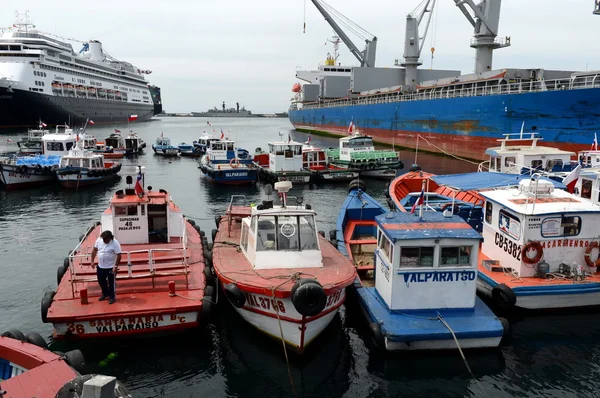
[256,215,319,251]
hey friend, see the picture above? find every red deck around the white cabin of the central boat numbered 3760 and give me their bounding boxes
[213,211,356,298]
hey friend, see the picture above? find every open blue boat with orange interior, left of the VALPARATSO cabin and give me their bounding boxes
[329,180,388,277]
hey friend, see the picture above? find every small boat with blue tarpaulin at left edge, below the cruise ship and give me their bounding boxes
[0,127,76,190]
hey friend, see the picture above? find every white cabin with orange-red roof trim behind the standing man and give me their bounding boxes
[101,179,185,244]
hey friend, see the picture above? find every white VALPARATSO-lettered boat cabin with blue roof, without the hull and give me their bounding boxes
[375,212,482,310]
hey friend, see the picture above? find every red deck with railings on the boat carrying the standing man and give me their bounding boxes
[48,223,206,322]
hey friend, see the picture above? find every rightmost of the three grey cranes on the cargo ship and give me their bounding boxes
[454,0,510,73]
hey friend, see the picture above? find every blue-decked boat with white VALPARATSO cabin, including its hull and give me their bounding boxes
[354,209,508,351]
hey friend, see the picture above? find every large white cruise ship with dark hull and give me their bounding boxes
[0,22,155,127]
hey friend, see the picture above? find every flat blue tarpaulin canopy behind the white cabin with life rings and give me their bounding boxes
[431,171,566,191]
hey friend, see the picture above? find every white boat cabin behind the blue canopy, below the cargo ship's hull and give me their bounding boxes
[480,133,576,174]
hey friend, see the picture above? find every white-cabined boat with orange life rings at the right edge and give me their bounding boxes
[478,175,600,309]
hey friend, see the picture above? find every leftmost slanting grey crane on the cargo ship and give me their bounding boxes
[311,0,377,68]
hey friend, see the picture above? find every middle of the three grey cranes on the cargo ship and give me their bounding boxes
[401,0,437,87]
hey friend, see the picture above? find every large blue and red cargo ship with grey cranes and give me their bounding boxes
[289,0,600,160]
